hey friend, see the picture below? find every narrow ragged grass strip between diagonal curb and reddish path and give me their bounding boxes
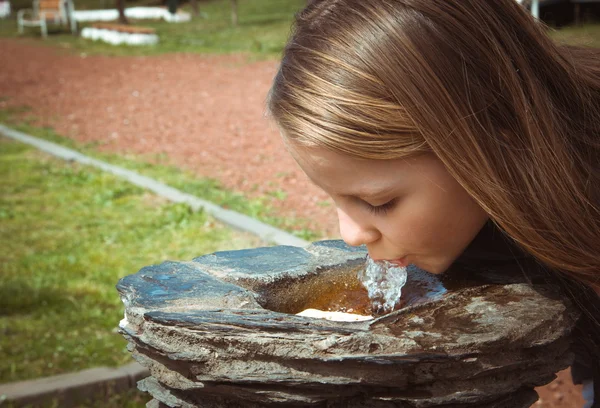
[0,107,324,241]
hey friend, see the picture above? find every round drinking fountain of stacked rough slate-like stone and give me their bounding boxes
[117,241,578,408]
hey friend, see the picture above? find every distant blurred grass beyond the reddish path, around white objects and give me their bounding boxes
[0,0,306,58]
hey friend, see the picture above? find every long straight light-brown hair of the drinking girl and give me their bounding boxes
[268,0,600,289]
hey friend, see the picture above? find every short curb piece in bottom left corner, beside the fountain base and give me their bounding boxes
[0,362,150,406]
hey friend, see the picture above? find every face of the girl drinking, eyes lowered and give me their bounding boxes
[288,143,488,273]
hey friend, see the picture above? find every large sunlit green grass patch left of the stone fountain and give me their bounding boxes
[0,139,259,382]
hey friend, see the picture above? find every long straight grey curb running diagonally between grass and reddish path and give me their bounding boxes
[0,123,309,247]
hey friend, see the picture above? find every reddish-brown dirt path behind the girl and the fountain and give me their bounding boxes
[0,40,583,408]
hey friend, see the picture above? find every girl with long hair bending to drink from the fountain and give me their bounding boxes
[268,0,600,407]
